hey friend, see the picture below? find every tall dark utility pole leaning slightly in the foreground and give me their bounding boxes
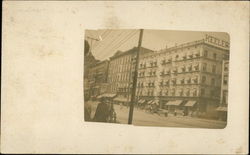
[128,29,143,124]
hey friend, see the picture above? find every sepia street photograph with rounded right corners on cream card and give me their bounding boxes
[83,29,230,129]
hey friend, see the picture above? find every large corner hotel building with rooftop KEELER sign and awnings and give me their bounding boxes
[137,36,229,116]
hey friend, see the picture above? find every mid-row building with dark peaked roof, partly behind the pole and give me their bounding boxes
[108,47,153,101]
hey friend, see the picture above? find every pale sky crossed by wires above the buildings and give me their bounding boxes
[85,29,229,60]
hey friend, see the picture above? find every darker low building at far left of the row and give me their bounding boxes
[88,60,109,97]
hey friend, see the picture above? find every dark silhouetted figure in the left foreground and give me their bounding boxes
[93,98,110,122]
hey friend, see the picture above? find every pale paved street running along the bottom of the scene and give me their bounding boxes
[88,102,226,129]
